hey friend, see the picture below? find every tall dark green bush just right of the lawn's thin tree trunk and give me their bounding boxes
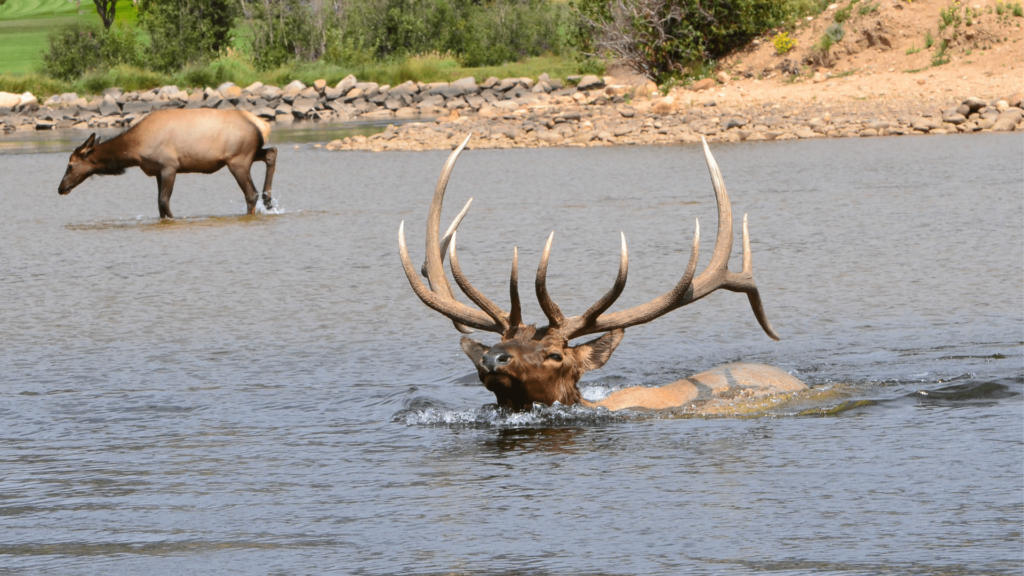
[138,0,238,72]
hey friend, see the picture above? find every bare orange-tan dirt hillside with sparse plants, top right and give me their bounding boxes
[667,0,1024,107]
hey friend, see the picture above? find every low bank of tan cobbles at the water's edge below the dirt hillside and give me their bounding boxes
[326,91,1024,152]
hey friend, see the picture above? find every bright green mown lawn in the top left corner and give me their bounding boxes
[0,0,136,74]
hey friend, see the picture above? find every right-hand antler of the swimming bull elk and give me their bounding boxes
[537,138,779,340]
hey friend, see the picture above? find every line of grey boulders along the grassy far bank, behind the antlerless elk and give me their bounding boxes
[0,74,614,132]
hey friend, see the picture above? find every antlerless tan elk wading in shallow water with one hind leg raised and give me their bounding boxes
[57,109,278,218]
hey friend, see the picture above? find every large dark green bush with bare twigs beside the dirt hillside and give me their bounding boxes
[569,0,798,83]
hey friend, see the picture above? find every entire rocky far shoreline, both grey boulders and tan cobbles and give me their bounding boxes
[0,75,1024,151]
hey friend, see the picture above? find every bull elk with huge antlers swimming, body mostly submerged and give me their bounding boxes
[398,137,807,410]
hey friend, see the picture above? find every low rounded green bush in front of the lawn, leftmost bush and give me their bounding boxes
[43,23,139,80]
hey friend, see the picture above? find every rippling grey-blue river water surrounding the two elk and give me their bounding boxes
[0,134,1024,574]
